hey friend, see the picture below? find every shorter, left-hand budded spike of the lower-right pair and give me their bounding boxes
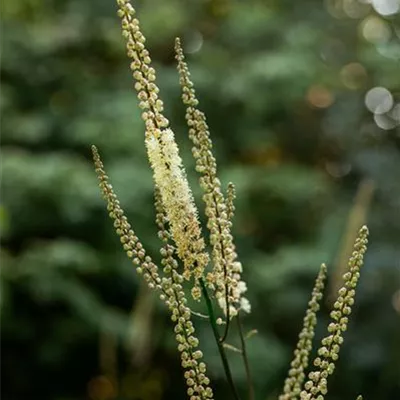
[279,264,326,400]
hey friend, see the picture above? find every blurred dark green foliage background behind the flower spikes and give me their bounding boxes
[0,0,400,400]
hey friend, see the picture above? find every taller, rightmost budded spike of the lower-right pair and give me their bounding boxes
[300,226,368,400]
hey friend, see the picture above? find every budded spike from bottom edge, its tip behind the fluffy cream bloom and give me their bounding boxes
[155,188,213,400]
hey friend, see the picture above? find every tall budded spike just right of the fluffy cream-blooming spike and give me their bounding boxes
[175,39,250,319]
